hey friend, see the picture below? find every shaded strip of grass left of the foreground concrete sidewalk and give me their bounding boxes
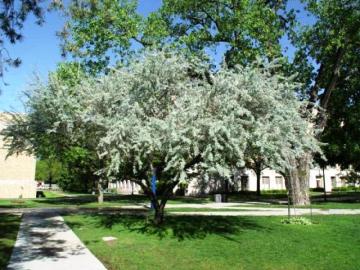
[0,214,21,269]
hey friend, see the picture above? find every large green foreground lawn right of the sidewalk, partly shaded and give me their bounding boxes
[65,215,360,270]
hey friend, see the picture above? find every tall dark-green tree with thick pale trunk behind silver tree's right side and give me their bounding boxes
[287,0,360,204]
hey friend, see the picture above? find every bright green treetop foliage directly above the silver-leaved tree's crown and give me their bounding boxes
[61,0,294,73]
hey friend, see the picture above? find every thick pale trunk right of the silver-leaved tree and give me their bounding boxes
[285,154,312,205]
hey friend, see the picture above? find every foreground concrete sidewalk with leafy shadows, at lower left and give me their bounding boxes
[7,212,106,270]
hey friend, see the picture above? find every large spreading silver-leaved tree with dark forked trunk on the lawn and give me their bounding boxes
[8,49,319,223]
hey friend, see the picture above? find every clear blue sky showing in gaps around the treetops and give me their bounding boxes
[0,0,314,112]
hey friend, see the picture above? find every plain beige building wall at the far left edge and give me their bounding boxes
[0,113,36,198]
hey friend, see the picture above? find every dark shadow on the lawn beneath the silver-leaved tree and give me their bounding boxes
[68,214,268,241]
